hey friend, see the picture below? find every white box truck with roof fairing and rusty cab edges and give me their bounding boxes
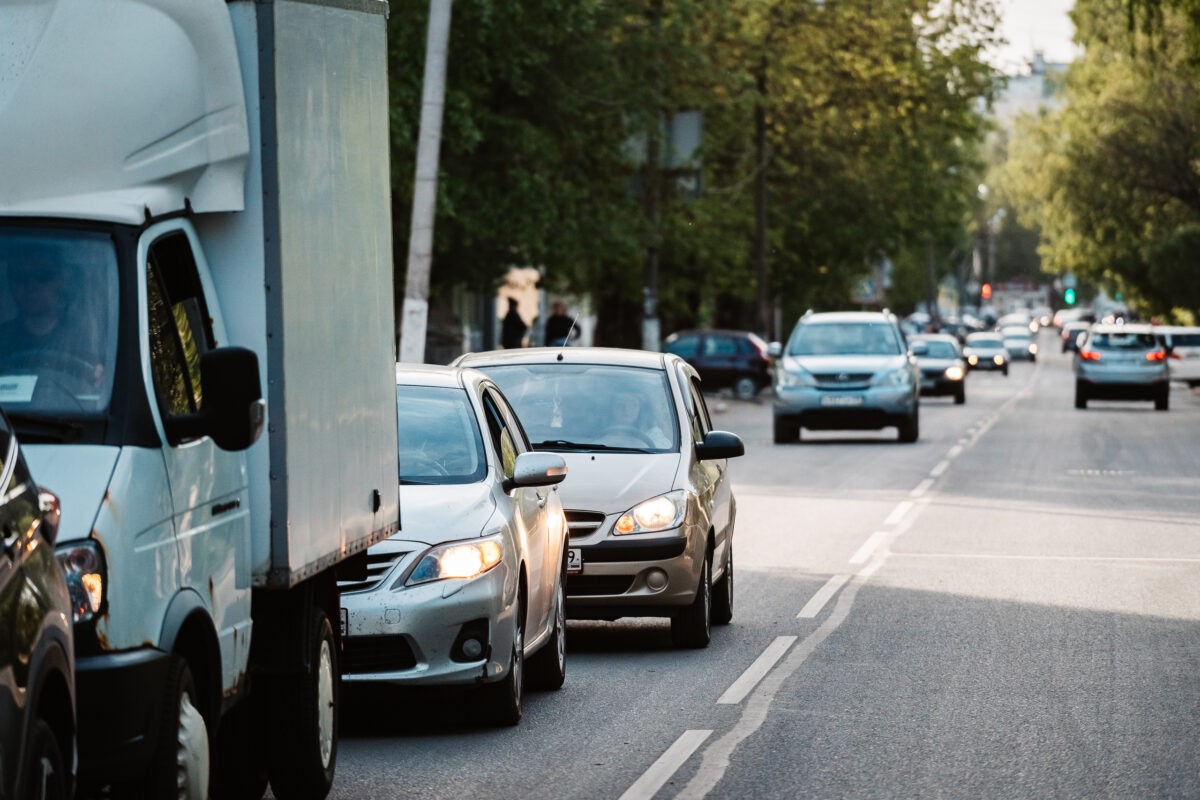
[0,0,400,798]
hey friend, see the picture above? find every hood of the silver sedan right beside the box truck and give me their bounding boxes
[391,481,496,545]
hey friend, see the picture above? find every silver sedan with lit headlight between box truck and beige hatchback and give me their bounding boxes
[340,365,566,724]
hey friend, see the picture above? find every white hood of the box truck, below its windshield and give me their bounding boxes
[22,445,121,542]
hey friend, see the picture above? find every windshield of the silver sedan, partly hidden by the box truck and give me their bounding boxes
[396,386,487,485]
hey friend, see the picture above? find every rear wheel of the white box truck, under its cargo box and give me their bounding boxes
[270,606,338,800]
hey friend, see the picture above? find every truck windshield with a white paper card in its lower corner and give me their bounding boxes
[0,227,119,417]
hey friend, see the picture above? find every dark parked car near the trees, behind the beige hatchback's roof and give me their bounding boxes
[662,330,770,399]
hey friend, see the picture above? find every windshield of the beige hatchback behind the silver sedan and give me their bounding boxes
[484,363,679,452]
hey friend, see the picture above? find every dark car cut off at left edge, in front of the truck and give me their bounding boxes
[0,413,76,799]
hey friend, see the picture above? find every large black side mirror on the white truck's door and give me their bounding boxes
[199,347,266,451]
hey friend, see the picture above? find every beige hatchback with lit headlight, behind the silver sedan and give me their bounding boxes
[455,348,745,648]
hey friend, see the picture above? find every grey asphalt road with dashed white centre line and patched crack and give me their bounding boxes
[331,333,1200,800]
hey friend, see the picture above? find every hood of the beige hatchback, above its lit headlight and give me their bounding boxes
[558,452,682,513]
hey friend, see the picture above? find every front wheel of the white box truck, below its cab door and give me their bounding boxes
[128,654,209,800]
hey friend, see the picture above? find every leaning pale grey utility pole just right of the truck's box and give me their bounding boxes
[397,0,452,363]
